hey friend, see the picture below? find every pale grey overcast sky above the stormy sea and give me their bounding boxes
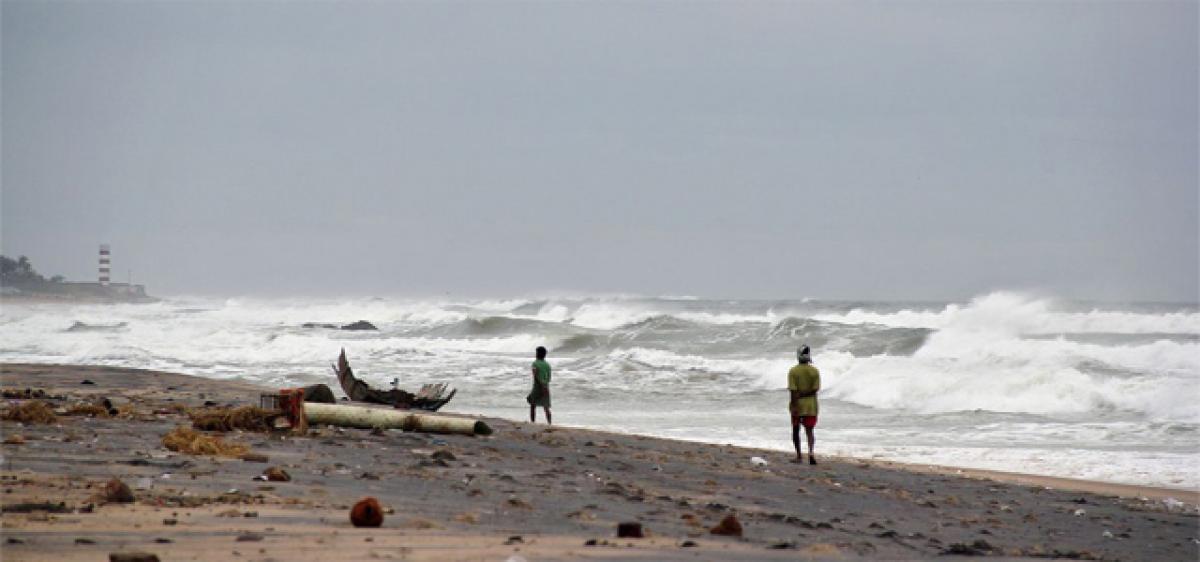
[0,0,1200,301]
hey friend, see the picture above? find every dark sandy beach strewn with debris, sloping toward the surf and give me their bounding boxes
[0,364,1200,561]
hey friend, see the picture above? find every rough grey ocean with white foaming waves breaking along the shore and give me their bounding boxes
[0,292,1200,489]
